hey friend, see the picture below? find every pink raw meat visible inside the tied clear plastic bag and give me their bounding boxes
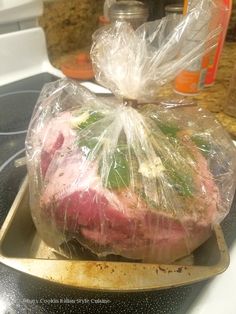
[38,114,219,263]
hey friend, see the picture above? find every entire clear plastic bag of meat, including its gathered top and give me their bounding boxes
[26,1,236,263]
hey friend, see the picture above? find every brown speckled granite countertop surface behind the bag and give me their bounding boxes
[51,42,236,137]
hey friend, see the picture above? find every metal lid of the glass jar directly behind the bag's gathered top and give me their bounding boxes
[108,1,148,20]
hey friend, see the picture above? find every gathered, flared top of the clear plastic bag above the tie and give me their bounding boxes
[91,1,224,101]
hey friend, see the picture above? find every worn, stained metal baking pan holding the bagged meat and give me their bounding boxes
[0,178,229,291]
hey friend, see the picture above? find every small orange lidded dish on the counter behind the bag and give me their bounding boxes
[61,52,94,80]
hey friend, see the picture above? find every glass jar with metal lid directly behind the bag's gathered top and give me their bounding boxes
[108,0,148,29]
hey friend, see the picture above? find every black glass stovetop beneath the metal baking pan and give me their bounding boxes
[0,73,236,314]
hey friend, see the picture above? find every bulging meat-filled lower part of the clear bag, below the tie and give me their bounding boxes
[27,80,235,262]
